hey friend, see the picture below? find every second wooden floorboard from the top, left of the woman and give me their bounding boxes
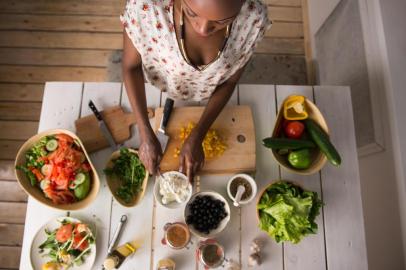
[0,14,120,33]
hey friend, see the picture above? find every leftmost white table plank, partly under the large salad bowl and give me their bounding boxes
[19,82,82,269]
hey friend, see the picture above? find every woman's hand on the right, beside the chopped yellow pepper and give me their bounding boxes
[179,131,204,183]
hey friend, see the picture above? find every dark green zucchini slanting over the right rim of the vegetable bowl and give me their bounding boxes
[304,118,341,167]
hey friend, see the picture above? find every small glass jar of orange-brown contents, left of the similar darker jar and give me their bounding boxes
[161,222,193,249]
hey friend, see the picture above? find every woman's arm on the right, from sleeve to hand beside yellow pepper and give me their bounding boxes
[179,68,244,181]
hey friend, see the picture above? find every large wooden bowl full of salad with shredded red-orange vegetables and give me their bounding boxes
[15,130,99,210]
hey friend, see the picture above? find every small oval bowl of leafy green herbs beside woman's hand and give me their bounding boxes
[104,148,149,207]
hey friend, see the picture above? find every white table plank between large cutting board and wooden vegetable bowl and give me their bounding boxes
[239,85,283,270]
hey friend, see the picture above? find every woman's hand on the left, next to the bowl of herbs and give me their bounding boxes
[138,131,162,175]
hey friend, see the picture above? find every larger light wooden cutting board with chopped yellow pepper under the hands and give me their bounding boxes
[155,106,255,174]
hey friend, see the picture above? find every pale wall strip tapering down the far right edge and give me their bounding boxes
[378,0,406,265]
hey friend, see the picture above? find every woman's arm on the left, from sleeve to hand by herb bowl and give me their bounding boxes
[122,31,162,174]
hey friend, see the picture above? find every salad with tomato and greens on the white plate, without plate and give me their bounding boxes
[38,219,95,269]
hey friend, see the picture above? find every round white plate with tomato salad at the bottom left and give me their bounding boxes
[30,217,96,270]
